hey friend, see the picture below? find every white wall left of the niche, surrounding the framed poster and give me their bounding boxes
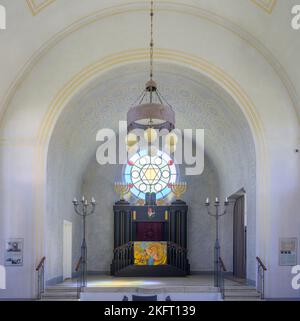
[0,146,36,299]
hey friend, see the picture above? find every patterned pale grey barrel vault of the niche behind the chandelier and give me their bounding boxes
[48,64,256,192]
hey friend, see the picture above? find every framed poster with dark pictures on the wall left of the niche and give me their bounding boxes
[4,238,24,266]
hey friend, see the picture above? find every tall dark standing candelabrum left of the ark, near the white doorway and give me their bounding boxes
[73,196,96,287]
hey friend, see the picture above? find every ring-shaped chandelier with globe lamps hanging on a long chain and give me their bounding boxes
[127,1,177,150]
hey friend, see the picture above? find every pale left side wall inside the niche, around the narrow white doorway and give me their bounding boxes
[45,126,82,282]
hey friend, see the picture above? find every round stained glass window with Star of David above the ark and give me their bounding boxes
[124,150,177,199]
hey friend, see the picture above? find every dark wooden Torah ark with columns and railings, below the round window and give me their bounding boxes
[111,201,190,276]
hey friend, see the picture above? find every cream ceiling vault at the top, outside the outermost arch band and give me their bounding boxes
[0,0,300,123]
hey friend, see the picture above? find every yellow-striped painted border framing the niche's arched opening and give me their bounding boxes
[33,49,270,272]
